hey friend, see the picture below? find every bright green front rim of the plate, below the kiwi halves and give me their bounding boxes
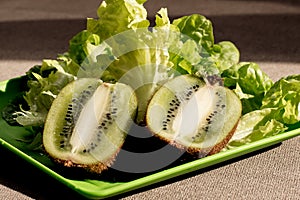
[0,125,300,198]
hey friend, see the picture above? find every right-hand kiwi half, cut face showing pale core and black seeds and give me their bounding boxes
[146,75,242,156]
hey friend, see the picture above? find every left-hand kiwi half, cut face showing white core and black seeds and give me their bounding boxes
[43,78,137,173]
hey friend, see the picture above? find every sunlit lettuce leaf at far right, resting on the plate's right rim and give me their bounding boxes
[225,74,300,149]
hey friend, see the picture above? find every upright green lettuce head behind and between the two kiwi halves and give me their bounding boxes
[9,0,239,126]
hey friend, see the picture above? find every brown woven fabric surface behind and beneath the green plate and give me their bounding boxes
[0,0,300,200]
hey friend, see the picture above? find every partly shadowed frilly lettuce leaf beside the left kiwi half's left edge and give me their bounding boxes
[14,56,78,126]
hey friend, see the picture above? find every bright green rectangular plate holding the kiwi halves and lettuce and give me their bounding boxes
[0,77,300,199]
